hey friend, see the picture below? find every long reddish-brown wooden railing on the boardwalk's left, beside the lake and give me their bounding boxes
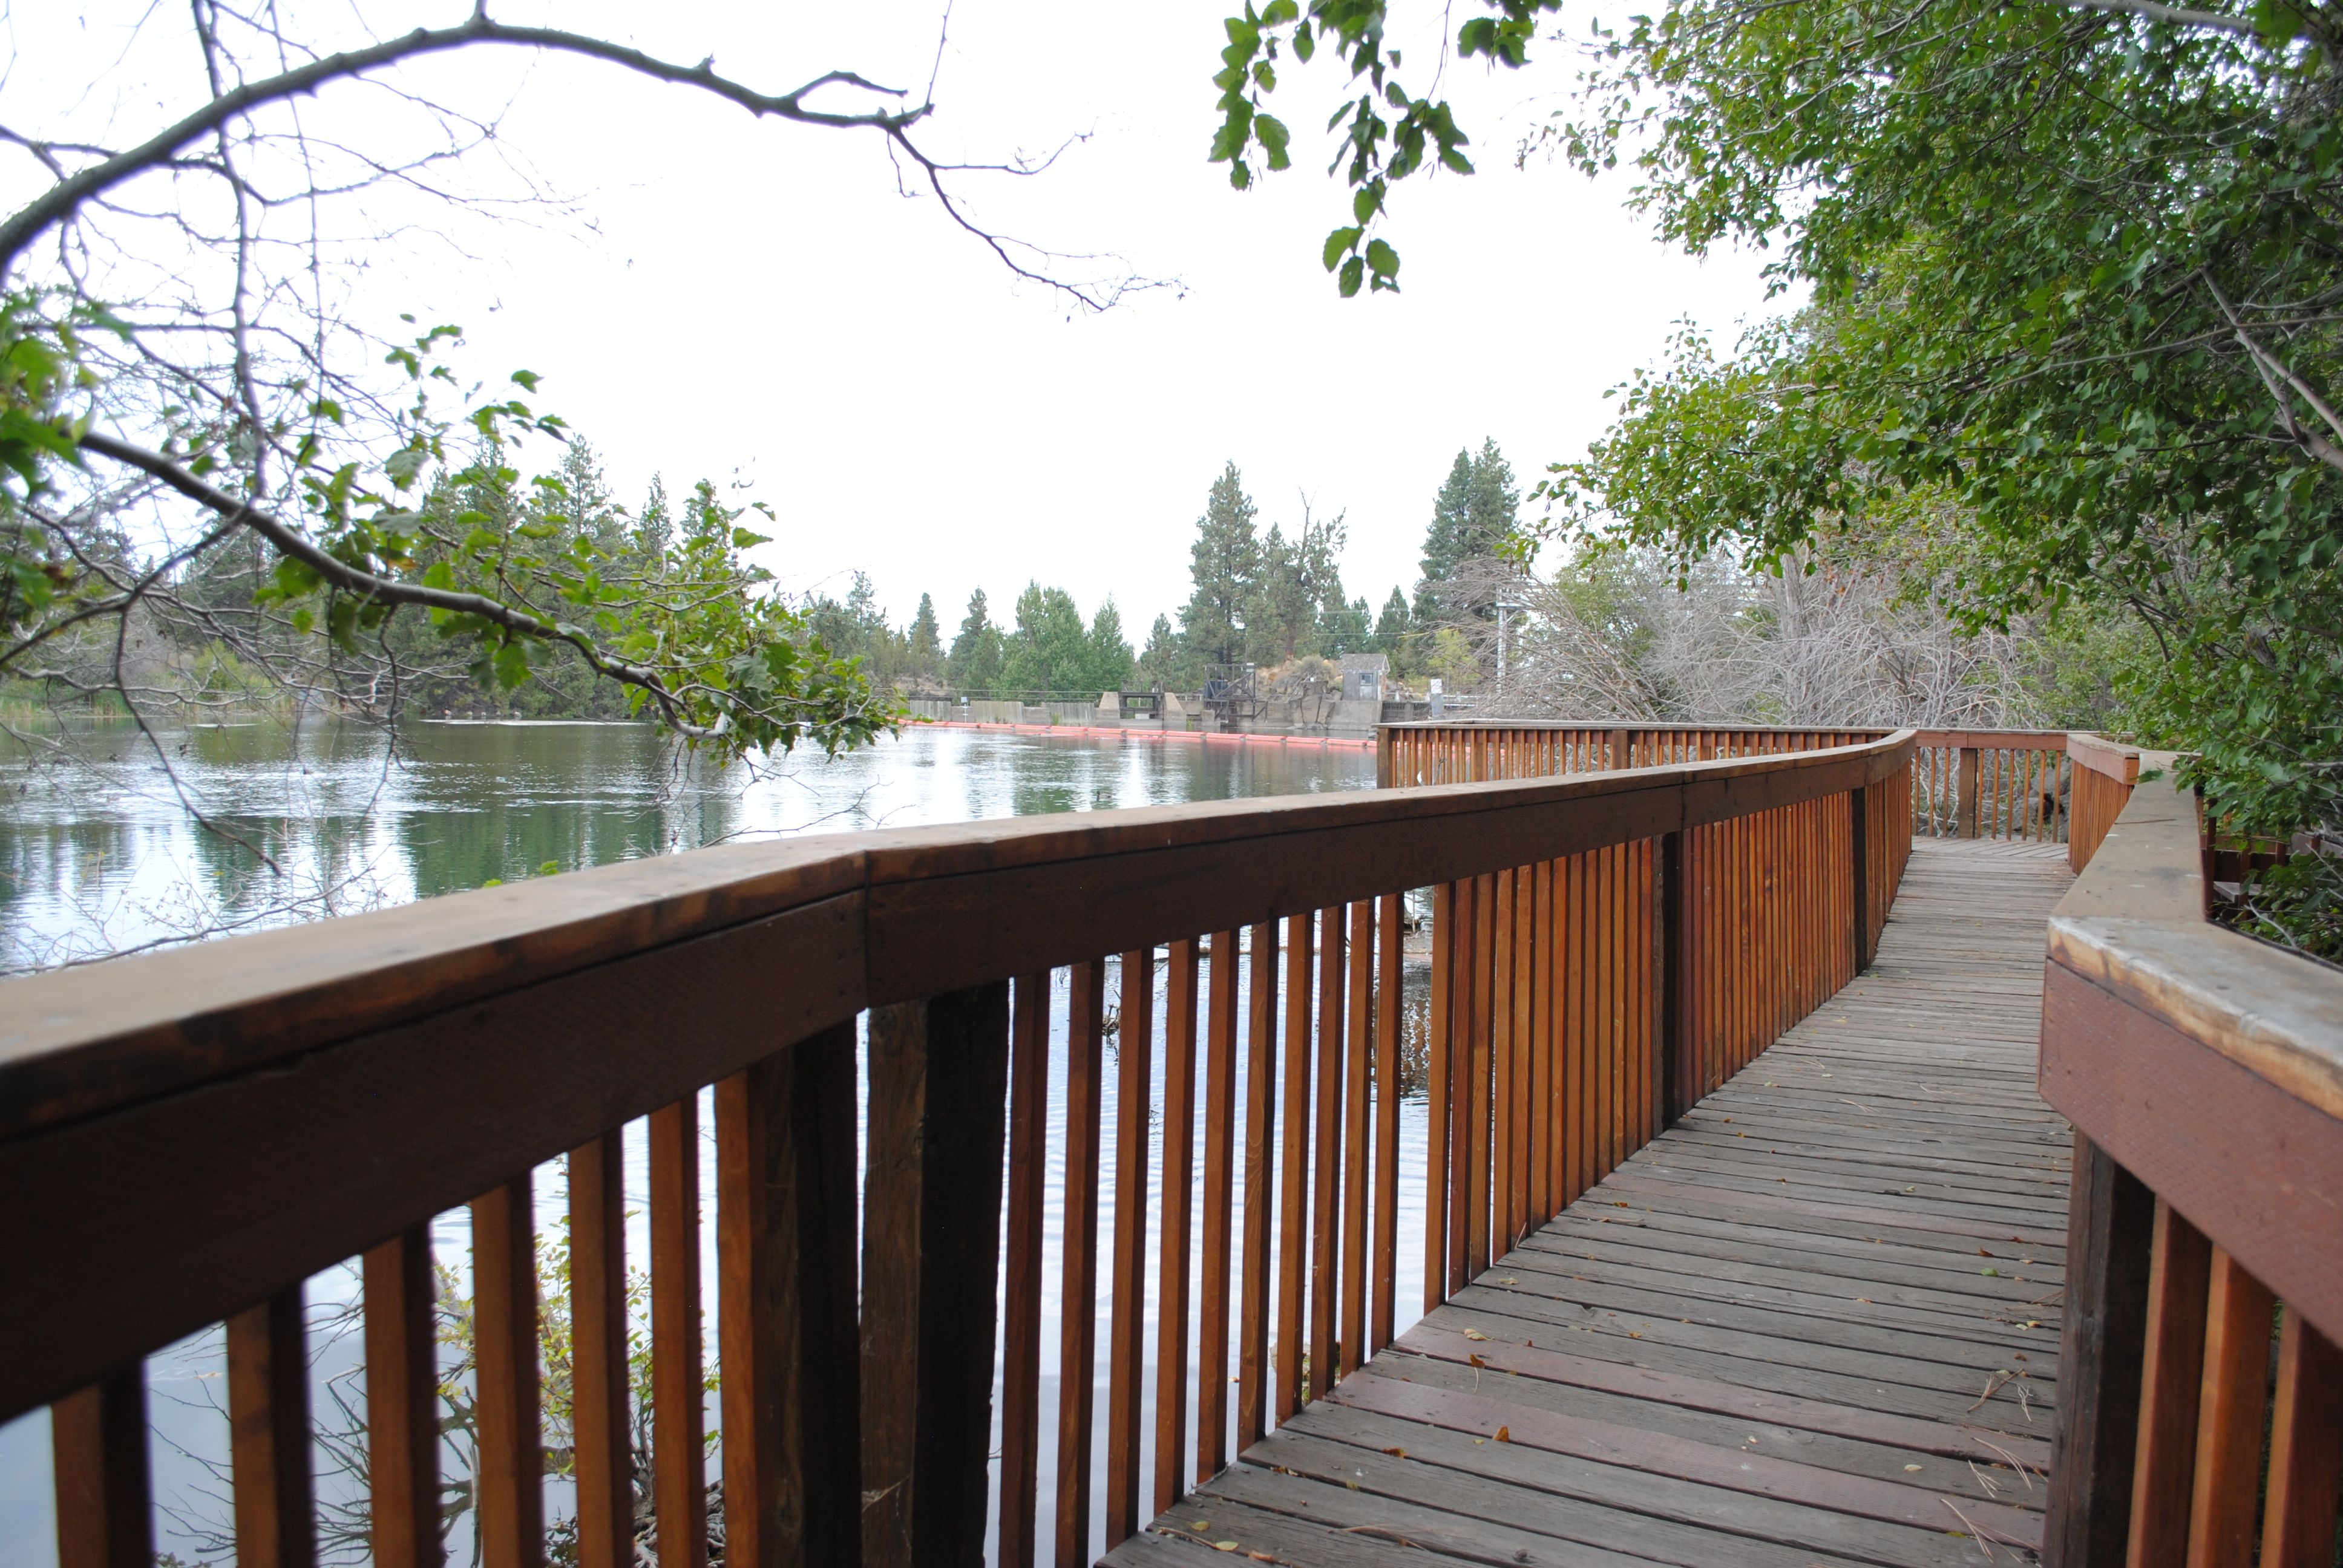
[0,731,1912,1568]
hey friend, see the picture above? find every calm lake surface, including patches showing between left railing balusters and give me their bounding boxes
[0,724,1424,1563]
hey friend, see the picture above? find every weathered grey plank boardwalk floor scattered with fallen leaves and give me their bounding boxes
[1108,841,2071,1568]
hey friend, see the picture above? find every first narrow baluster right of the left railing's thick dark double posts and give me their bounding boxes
[1000,973,1050,1568]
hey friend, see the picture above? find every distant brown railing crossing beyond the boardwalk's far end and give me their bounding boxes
[1382,719,2088,844]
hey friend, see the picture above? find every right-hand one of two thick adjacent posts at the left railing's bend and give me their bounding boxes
[862,982,1010,1566]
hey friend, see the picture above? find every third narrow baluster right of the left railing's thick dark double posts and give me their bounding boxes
[1106,949,1155,1552]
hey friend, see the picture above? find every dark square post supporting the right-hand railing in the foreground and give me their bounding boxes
[2043,1132,2155,1568]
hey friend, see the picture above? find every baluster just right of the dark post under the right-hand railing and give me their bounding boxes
[2127,1191,2212,1568]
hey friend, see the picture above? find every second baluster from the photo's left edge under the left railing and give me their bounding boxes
[228,1284,316,1568]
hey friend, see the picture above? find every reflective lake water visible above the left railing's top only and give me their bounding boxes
[0,719,1373,970]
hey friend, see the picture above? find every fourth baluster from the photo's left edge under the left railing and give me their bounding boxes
[471,1174,546,1568]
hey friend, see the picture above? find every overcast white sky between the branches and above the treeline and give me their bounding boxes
[7,0,1766,642]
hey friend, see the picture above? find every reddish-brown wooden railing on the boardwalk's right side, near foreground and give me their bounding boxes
[2041,736,2343,1568]
